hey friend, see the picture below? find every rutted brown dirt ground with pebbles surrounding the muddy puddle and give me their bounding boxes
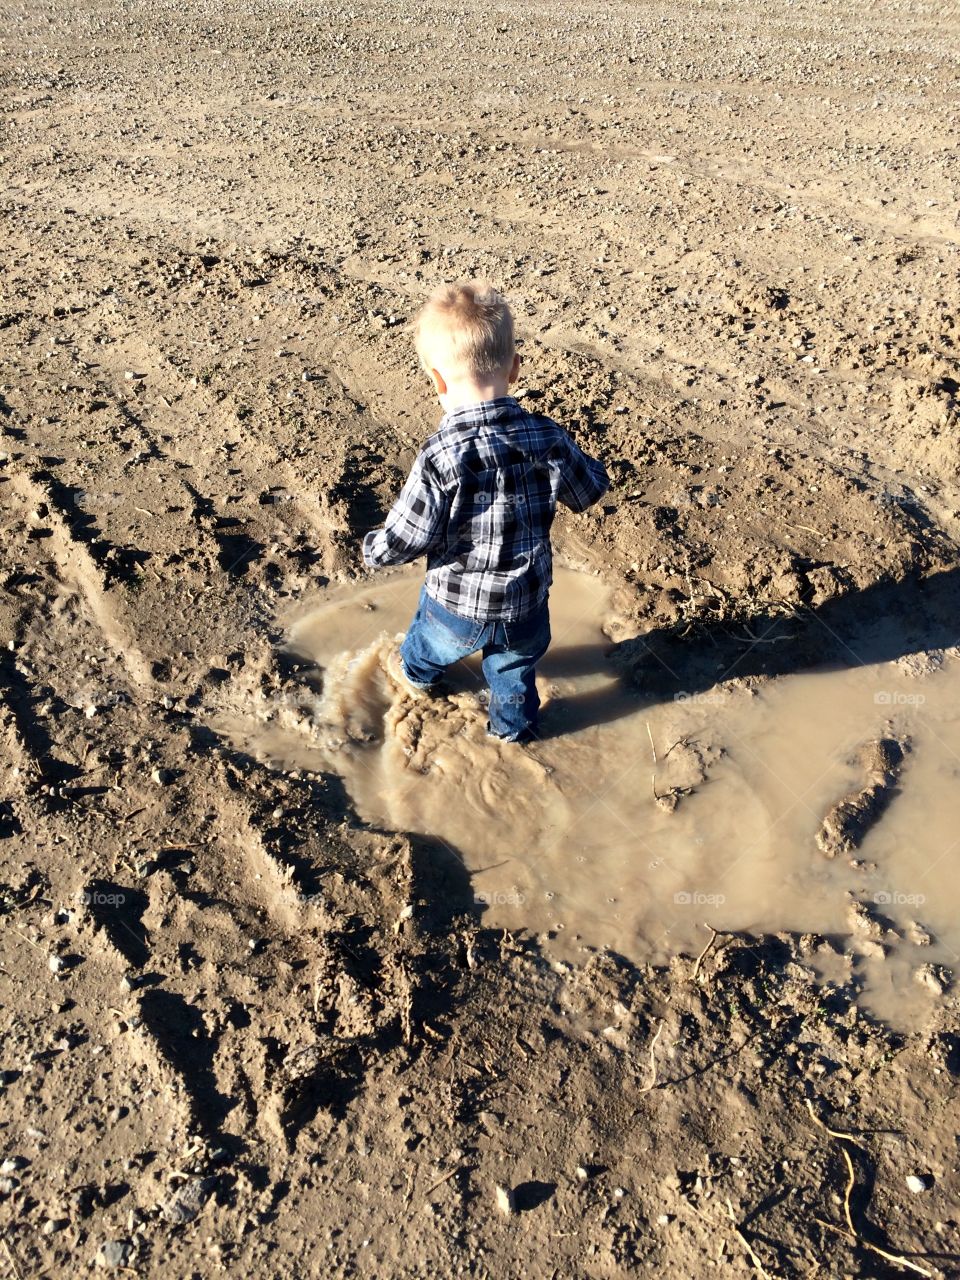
[0,0,960,1280]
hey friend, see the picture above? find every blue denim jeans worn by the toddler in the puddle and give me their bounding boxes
[401,589,550,742]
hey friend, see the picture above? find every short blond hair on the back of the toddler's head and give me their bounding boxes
[413,280,516,378]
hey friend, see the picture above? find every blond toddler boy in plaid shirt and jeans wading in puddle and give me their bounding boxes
[364,282,609,742]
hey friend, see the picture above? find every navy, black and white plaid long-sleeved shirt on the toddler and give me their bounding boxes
[364,396,609,622]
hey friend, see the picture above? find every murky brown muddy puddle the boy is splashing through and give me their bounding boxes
[218,568,960,1027]
